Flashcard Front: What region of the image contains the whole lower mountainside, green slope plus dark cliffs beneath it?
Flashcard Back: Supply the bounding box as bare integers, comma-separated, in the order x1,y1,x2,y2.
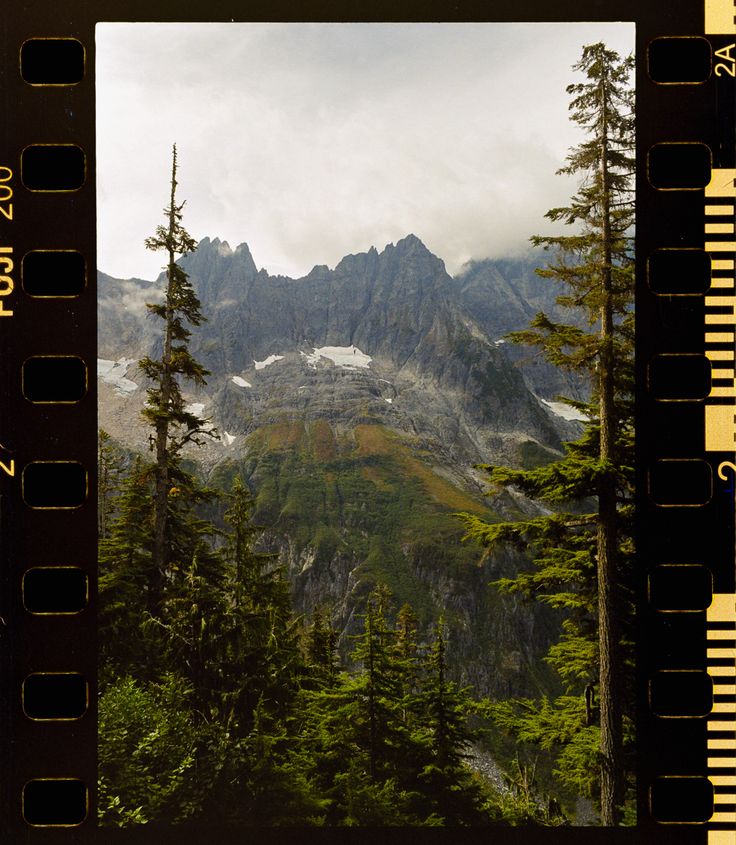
210,419,557,695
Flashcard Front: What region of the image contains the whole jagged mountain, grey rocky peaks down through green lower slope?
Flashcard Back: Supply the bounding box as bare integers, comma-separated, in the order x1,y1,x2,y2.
99,235,577,695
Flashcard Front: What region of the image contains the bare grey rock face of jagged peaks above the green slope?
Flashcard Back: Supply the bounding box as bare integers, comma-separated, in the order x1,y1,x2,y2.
99,235,570,465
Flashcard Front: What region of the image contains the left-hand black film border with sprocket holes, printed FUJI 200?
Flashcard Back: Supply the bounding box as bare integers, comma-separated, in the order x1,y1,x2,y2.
0,16,96,841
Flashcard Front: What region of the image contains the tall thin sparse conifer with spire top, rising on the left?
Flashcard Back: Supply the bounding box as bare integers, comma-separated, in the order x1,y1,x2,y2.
139,145,217,613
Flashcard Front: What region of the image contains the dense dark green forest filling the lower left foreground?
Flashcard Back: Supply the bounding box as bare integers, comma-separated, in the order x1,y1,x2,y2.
99,446,563,826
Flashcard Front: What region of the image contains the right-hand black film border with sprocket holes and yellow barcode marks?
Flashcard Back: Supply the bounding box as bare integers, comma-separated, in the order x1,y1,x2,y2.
637,0,736,845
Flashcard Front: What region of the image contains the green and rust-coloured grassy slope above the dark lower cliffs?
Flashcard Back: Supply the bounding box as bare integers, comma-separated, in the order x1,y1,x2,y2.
212,420,494,622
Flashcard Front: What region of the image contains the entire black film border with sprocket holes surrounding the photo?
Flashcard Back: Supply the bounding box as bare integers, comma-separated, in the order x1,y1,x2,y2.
0,0,736,845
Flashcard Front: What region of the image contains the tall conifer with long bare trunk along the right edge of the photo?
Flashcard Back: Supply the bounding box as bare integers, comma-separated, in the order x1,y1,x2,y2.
465,43,634,825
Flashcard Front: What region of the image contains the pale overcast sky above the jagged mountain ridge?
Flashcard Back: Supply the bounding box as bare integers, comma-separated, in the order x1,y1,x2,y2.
96,23,634,279
